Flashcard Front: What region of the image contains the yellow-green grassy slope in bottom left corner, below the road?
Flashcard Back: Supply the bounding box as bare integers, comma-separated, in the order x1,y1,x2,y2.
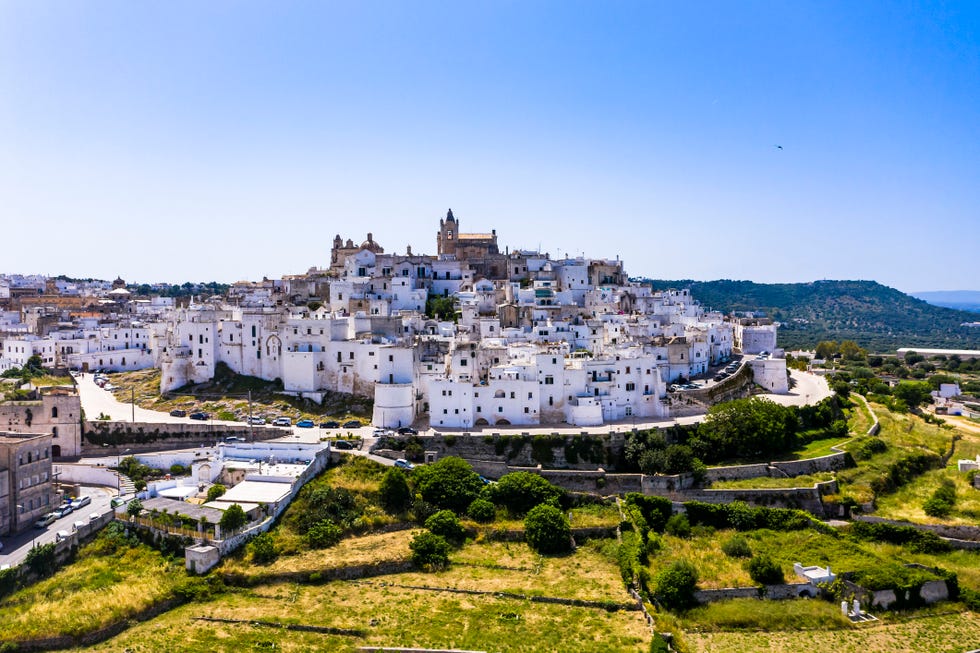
0,536,186,642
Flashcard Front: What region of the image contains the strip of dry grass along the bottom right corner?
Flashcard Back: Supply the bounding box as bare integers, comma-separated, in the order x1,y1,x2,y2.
684,606,980,653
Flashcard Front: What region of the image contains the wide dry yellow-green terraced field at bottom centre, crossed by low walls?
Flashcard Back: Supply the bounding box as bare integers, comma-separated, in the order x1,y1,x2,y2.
90,544,650,653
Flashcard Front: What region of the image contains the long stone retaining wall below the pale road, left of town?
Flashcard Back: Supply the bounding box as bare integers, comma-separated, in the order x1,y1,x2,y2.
82,421,288,456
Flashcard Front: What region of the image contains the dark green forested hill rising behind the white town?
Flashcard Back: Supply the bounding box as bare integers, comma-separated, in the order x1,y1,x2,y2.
643,279,980,352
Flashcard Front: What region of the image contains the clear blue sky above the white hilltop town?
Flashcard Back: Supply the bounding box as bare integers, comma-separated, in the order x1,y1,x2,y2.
0,0,980,291
